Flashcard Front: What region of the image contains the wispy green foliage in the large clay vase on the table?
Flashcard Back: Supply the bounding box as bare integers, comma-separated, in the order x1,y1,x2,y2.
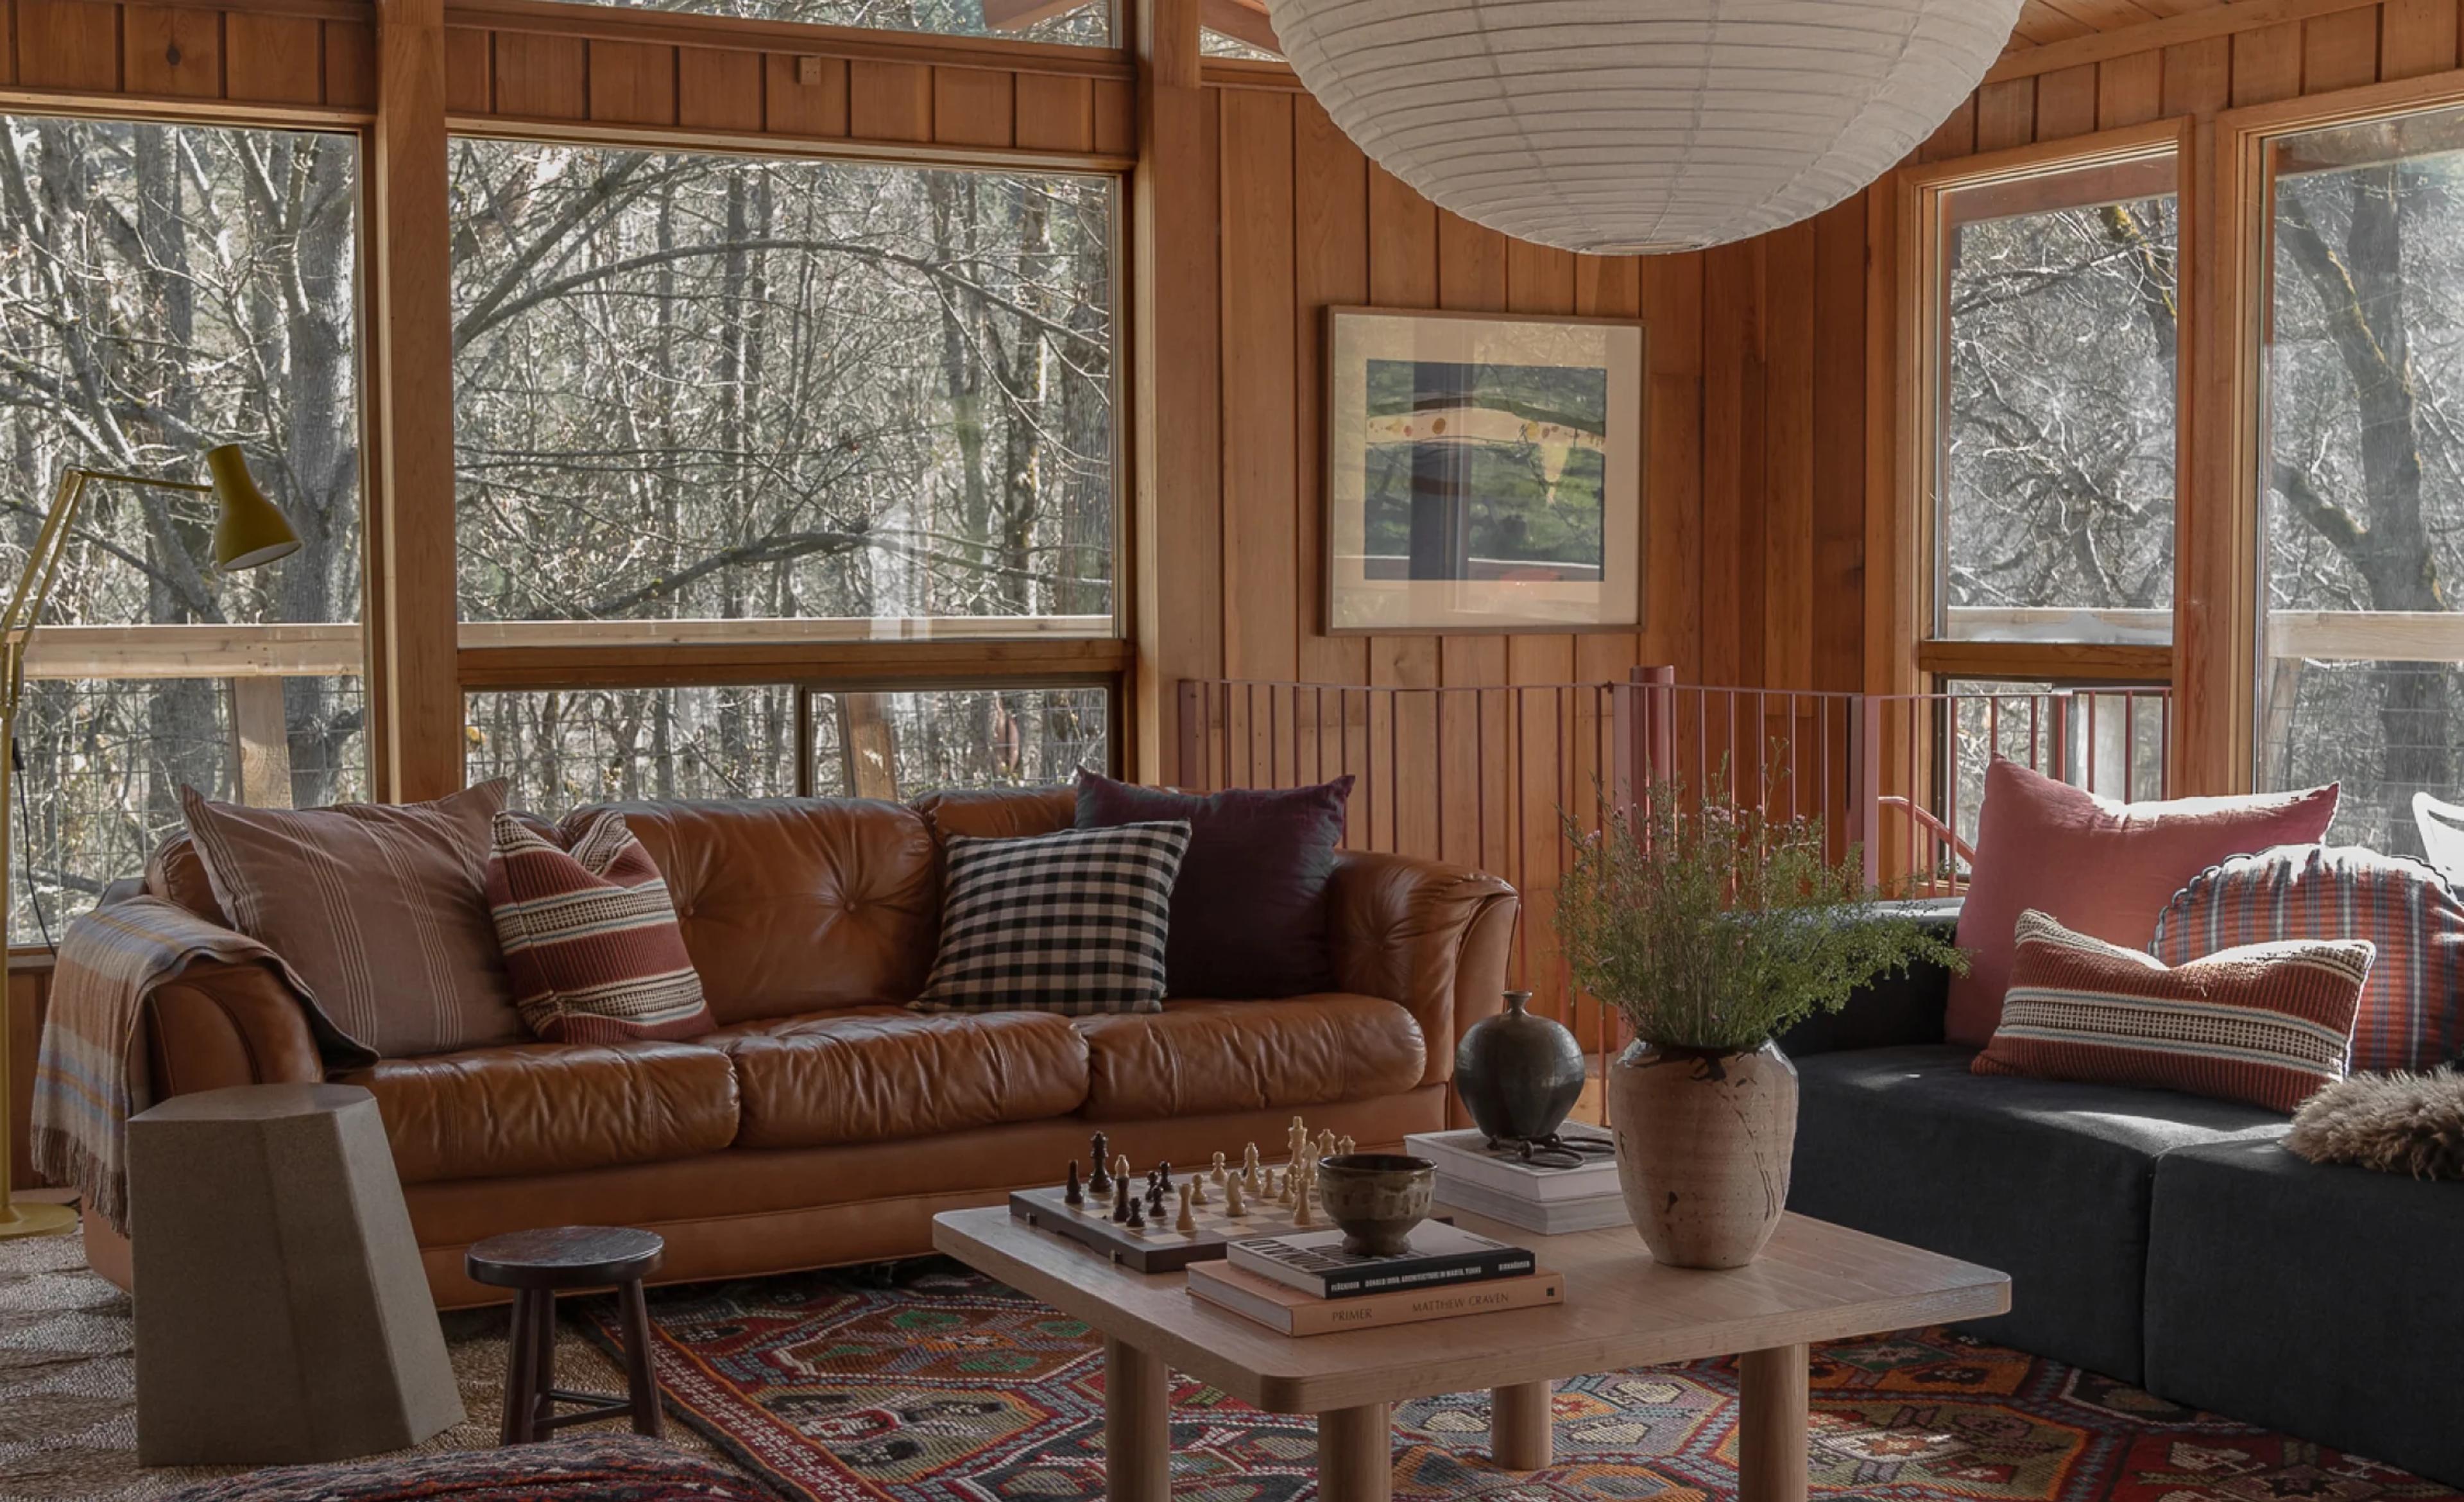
1557,775,1966,1053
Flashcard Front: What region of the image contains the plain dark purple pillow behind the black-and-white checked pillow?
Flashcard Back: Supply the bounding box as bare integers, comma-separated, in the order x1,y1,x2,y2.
1077,772,1353,1001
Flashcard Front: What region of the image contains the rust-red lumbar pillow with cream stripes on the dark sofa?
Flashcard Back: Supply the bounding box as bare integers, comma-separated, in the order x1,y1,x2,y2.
1969,910,2375,1112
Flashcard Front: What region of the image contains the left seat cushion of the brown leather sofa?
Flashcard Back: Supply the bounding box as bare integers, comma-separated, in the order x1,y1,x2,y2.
335,1043,737,1184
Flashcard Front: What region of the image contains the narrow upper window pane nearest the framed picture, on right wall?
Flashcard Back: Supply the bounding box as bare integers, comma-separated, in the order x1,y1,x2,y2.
1929,150,2180,644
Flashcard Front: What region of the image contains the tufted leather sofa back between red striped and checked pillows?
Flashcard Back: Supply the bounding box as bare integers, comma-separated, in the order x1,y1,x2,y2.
586,799,941,1024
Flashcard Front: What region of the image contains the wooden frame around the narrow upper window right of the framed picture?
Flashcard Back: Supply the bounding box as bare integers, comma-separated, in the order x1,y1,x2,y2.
1868,118,2200,691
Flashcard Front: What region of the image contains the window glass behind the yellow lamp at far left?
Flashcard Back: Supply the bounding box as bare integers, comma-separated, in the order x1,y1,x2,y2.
0,116,367,940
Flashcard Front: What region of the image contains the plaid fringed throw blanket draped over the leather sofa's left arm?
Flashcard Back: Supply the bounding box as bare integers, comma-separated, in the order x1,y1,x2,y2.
32,898,335,1233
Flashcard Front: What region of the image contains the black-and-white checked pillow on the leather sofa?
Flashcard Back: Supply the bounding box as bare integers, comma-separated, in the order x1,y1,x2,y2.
914,819,1190,1016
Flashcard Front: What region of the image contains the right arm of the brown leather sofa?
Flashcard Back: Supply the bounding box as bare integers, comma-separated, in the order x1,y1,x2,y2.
1328,851,1520,1085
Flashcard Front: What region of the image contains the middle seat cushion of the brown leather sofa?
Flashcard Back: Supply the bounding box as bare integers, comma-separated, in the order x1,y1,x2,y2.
702,1006,1086,1147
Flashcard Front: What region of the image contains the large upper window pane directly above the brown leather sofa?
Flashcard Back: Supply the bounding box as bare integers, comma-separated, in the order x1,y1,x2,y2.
454,141,1116,639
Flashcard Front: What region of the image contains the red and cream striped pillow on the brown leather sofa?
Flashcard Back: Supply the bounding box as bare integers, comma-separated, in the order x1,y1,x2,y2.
488,811,717,1043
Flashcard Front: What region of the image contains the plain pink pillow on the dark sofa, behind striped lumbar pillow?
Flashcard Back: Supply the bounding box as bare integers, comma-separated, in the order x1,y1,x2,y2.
1944,757,2336,1048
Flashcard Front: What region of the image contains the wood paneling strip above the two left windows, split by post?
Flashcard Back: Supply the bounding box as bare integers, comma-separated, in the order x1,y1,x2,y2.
0,0,1136,165
